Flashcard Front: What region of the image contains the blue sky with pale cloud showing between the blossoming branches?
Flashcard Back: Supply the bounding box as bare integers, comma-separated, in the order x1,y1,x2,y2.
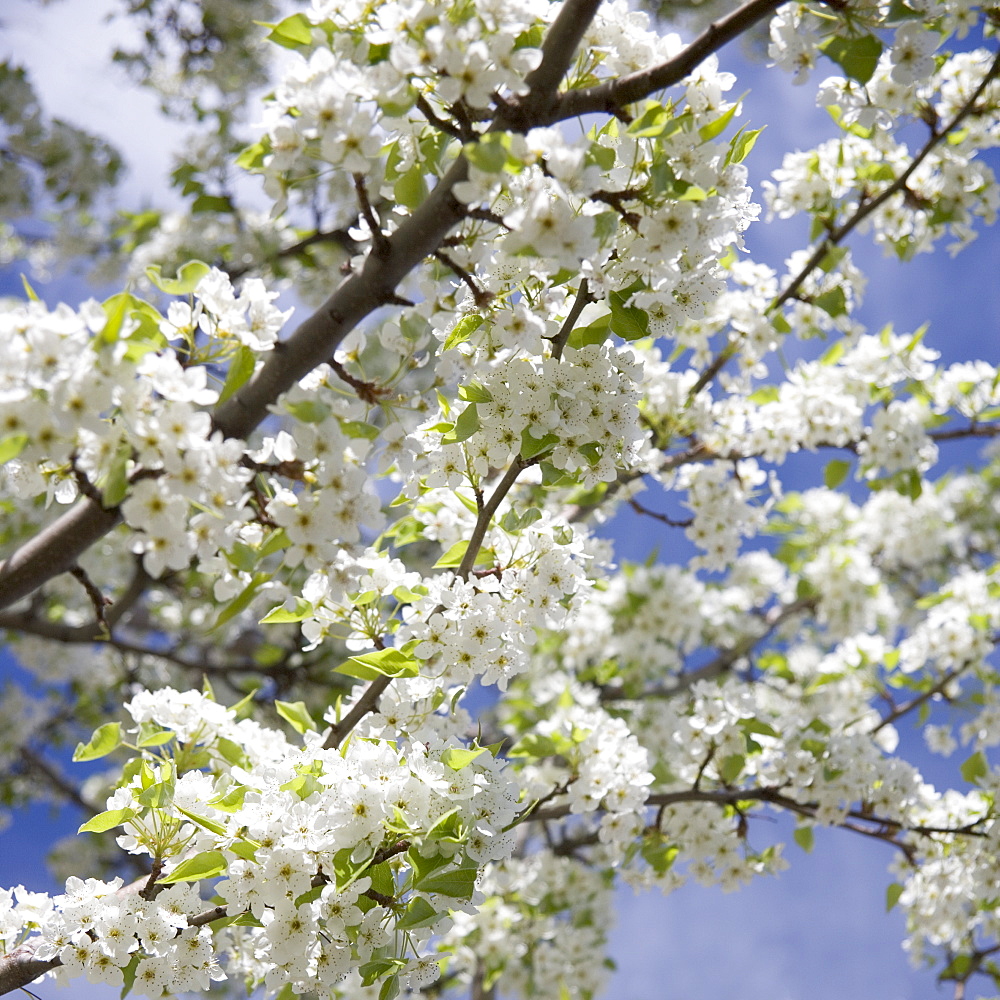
0,0,1000,1000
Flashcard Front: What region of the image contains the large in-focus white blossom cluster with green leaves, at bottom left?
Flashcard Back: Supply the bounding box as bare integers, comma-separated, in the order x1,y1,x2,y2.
0,689,517,997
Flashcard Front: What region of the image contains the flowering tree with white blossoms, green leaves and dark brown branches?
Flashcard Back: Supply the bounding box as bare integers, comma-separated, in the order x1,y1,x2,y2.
0,0,1000,1000
